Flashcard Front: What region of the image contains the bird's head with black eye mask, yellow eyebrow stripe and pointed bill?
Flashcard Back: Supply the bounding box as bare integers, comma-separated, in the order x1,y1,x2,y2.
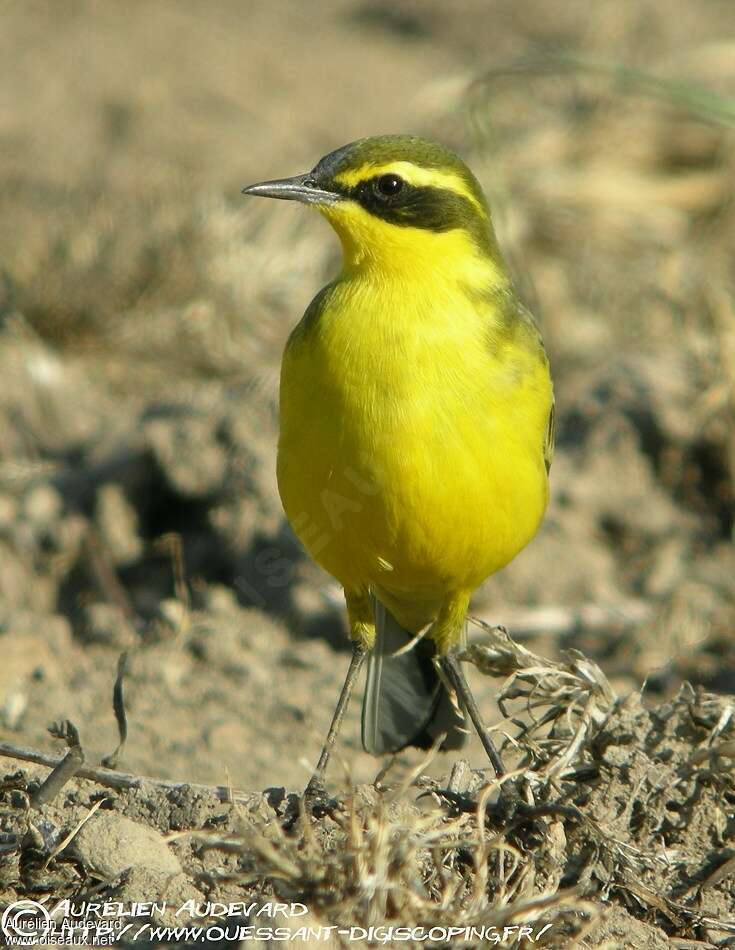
243,135,501,280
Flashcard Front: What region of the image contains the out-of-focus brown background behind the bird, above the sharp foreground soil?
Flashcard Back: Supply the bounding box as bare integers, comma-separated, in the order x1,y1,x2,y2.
0,0,735,789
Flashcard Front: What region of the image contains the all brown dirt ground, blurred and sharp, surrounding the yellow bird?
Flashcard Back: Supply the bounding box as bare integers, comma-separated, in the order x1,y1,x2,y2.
0,0,735,947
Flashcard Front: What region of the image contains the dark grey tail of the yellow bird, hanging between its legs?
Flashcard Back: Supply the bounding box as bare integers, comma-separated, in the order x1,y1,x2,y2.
362,599,467,755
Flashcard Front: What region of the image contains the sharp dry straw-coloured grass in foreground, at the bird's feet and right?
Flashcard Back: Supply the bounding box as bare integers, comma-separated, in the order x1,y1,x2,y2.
139,629,735,946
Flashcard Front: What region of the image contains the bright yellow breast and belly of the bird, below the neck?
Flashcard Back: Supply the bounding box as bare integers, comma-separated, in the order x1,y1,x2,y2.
278,276,551,624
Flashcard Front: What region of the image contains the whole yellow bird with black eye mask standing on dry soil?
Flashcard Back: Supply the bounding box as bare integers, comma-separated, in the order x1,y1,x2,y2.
243,135,554,794
